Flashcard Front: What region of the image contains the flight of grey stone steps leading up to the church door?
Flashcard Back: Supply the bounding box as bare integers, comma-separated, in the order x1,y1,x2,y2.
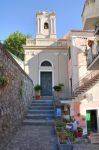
23,100,54,126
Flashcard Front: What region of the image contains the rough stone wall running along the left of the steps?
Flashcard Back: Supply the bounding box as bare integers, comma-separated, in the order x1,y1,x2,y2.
0,45,33,150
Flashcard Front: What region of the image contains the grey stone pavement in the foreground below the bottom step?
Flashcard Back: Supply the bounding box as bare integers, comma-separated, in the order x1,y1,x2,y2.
7,125,57,150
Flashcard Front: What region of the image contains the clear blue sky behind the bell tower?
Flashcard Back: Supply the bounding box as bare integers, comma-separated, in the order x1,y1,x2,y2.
0,0,84,40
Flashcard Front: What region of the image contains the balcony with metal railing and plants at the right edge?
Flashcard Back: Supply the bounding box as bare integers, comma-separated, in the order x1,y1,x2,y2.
87,38,99,70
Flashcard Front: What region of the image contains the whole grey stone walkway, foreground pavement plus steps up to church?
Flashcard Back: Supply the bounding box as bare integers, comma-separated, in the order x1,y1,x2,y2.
6,100,57,150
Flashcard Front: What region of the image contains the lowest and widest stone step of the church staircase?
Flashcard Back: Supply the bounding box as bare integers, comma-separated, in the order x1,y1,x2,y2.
23,119,54,126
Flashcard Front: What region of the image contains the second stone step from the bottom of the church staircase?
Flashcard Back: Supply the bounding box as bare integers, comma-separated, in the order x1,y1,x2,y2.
25,113,54,119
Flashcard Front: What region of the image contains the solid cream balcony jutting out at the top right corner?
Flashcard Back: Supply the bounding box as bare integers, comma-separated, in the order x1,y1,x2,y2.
82,0,99,30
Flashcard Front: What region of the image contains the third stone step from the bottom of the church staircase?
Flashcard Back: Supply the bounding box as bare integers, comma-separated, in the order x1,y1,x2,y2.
28,109,54,114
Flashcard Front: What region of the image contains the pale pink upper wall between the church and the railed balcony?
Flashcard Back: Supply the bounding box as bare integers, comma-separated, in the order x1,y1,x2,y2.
71,36,91,89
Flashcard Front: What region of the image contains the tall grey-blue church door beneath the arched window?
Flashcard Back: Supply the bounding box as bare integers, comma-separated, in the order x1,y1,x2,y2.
40,72,52,96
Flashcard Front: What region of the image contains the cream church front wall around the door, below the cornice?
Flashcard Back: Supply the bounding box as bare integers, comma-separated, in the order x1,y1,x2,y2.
25,49,69,97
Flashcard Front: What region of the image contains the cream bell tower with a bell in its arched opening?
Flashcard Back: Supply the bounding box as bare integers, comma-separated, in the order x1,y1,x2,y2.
36,11,56,39
